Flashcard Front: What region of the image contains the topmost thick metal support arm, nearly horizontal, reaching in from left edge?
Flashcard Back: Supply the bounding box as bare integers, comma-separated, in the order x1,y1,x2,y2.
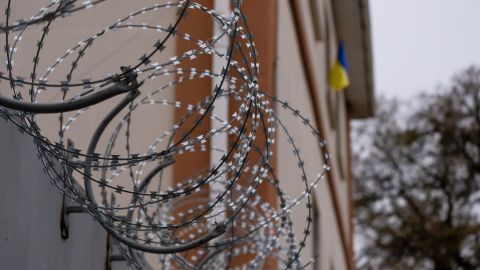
0,81,139,114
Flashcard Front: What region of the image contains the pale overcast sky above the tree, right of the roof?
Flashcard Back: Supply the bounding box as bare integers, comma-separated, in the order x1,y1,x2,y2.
370,0,480,98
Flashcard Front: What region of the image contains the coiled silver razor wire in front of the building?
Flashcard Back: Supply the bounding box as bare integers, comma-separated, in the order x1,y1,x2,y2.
0,0,329,269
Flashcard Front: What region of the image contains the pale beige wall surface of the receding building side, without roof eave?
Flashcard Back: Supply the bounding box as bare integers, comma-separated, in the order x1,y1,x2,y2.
277,0,350,269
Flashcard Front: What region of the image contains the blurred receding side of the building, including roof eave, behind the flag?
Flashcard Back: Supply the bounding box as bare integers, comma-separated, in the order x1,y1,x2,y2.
277,0,373,270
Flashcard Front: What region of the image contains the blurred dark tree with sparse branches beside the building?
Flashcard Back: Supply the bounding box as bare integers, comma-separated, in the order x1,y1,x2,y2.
352,68,480,269
